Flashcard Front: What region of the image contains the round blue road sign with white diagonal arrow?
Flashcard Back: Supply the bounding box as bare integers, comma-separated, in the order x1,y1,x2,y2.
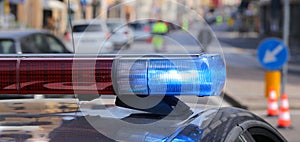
257,38,289,71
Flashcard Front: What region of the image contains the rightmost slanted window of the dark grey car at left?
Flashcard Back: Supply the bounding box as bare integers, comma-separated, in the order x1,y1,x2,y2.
45,35,65,53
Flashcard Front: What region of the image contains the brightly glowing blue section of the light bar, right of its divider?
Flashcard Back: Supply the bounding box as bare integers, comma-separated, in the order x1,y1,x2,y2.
148,59,212,95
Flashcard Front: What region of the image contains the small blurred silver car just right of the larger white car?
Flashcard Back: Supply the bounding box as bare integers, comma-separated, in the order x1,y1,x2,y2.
106,19,134,49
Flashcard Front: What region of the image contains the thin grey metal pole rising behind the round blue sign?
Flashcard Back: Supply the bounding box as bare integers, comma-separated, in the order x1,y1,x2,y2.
281,0,290,95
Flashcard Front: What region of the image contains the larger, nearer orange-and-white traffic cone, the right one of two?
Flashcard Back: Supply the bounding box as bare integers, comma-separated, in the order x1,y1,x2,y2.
278,94,291,128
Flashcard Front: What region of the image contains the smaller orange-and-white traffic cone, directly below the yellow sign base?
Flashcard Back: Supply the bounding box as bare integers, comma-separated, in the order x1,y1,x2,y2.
267,88,279,116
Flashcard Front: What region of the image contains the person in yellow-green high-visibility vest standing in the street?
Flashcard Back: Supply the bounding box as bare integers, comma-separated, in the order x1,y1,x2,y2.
152,21,168,52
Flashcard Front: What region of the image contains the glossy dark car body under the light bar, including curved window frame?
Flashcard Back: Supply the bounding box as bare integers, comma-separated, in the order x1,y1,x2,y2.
0,98,284,142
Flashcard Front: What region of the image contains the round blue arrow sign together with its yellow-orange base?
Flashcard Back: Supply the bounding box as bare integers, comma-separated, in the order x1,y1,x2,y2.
257,38,289,97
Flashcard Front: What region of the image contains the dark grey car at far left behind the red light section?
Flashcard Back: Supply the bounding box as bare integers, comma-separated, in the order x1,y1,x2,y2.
0,30,70,54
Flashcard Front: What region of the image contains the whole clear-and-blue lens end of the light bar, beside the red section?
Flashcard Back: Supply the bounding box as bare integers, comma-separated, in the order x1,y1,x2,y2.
115,55,226,96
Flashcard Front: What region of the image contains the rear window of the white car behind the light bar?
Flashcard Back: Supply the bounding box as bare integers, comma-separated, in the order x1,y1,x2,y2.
73,24,102,33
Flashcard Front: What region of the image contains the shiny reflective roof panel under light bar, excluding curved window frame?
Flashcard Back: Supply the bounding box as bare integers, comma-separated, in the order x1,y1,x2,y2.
0,99,217,142
